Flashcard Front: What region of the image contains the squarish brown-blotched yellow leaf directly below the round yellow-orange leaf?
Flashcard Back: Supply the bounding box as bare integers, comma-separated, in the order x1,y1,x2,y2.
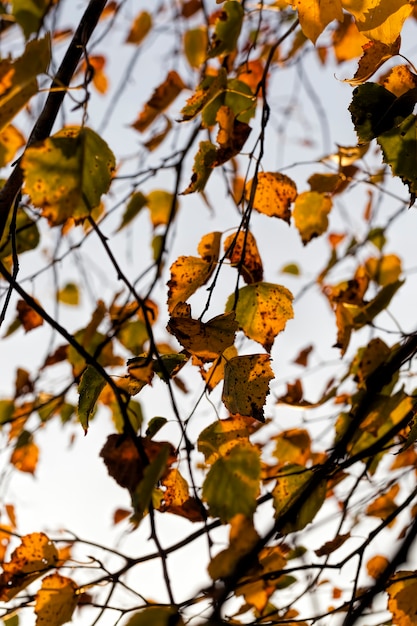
222,354,274,422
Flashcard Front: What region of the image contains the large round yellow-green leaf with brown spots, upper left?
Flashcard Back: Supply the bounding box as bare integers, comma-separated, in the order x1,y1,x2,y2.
22,127,115,226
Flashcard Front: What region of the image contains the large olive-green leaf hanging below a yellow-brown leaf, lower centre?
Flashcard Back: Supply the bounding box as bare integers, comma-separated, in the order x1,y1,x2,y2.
203,444,261,522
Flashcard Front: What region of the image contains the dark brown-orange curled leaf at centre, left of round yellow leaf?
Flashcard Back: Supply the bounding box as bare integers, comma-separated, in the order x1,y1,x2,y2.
167,309,237,361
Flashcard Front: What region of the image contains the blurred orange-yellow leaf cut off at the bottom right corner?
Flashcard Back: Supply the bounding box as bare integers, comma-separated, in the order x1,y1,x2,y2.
387,571,417,626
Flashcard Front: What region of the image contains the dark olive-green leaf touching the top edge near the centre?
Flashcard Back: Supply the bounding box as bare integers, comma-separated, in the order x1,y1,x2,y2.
208,0,244,59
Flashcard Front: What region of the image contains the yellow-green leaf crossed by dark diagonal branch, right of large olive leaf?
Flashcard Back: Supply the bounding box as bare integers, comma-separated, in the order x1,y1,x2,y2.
272,463,326,534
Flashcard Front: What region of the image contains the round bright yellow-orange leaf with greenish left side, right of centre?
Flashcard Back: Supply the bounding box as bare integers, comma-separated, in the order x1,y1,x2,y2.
226,282,294,352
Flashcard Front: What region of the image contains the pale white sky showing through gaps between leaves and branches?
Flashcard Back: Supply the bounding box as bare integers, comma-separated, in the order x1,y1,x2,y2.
0,1,417,626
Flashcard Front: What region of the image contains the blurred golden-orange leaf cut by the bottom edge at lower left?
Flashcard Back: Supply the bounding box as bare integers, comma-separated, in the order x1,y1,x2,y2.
35,573,77,626
